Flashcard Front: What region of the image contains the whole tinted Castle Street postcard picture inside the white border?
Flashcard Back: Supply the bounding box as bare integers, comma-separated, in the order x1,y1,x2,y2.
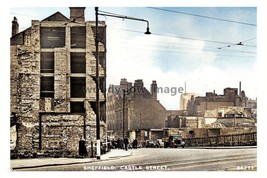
9,6,258,172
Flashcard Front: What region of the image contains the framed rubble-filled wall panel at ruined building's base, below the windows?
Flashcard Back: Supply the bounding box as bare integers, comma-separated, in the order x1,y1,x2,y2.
41,114,84,153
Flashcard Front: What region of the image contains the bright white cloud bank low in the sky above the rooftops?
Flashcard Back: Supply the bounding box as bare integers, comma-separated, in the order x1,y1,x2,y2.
107,23,256,109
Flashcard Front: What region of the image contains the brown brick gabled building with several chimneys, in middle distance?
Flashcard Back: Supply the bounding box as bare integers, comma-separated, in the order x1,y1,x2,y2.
107,79,167,138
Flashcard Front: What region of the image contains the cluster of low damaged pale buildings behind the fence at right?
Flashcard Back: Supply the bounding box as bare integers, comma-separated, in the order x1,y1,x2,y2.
175,82,257,131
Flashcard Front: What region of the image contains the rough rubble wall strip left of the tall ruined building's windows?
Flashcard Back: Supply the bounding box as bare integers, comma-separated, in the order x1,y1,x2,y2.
11,21,40,151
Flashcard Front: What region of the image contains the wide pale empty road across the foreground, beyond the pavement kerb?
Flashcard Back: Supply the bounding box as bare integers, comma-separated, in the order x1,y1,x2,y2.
16,148,257,171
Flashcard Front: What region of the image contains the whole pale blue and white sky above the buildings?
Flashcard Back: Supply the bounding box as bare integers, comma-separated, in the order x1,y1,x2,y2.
9,7,257,110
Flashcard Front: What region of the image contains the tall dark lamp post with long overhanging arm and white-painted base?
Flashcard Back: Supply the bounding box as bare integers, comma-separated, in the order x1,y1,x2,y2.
95,7,151,159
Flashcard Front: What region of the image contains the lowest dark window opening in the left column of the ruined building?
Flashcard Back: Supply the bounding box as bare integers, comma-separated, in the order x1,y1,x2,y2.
40,77,54,98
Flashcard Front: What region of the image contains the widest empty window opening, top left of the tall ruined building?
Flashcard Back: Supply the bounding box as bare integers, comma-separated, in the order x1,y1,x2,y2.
41,27,66,48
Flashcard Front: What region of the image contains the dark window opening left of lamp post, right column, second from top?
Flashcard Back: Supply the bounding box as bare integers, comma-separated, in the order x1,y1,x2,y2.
70,53,86,73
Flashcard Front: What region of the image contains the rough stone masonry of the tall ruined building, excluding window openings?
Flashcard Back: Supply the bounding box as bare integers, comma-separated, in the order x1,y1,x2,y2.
10,20,106,154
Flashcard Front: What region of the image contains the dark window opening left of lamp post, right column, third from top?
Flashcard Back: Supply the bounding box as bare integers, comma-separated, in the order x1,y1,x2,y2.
70,77,86,98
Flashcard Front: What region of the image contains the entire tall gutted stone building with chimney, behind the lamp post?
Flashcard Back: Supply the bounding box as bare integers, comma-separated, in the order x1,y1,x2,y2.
10,7,106,155
